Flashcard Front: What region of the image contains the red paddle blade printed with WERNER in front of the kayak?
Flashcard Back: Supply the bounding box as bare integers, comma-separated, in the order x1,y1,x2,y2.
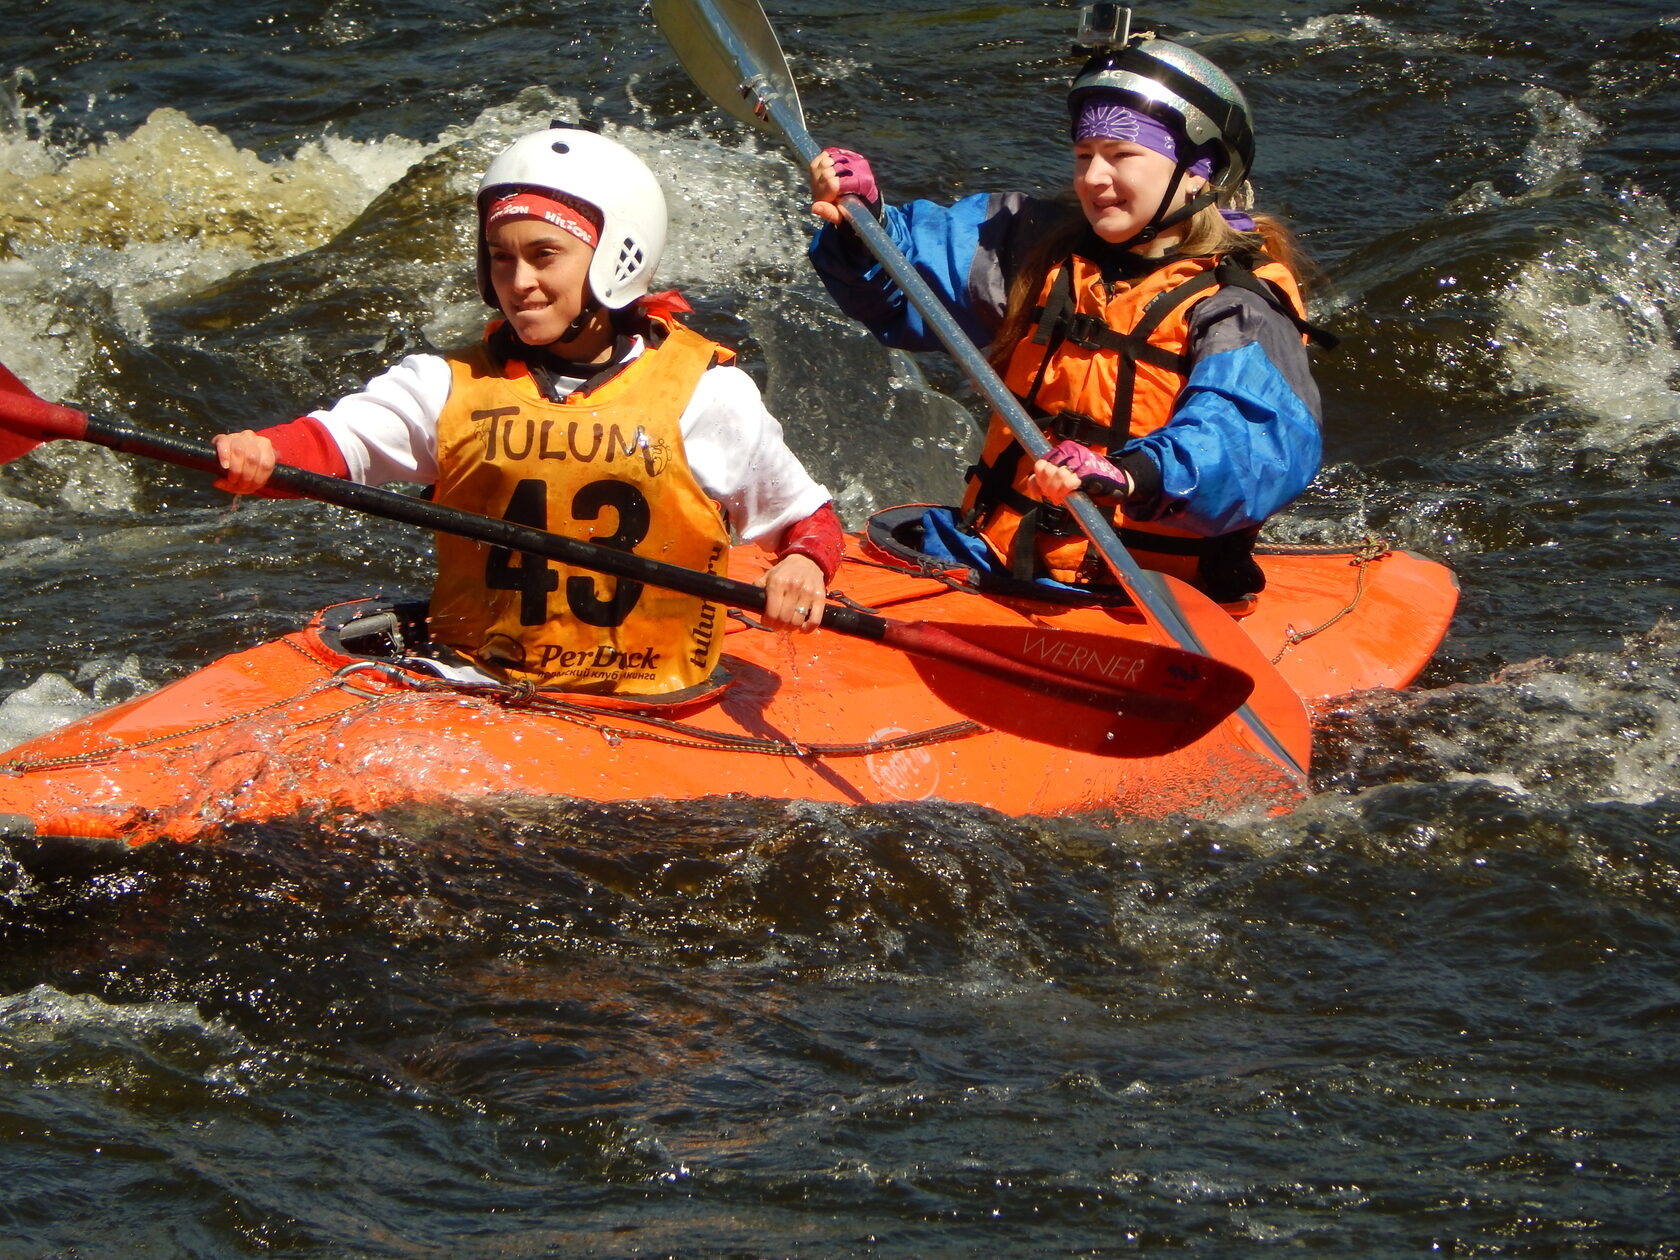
887,622,1253,758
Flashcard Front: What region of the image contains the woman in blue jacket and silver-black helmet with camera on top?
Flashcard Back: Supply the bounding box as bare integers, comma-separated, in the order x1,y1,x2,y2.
811,29,1320,601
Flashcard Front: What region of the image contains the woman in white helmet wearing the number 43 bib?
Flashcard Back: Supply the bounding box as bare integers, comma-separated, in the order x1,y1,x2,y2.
217,124,842,696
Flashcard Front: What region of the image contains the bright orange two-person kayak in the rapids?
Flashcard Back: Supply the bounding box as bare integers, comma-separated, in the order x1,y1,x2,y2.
0,517,1458,845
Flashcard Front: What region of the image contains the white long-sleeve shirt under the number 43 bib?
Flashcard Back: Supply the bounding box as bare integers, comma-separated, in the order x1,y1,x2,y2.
311,338,832,548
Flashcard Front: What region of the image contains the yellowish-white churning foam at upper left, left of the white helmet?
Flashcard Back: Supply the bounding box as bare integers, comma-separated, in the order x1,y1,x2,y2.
0,86,510,389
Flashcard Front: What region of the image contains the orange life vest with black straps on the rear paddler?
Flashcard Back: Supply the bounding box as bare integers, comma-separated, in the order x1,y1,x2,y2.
963,254,1307,583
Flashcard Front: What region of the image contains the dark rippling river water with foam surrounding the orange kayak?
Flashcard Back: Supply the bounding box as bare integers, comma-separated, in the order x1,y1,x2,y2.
0,0,1680,1260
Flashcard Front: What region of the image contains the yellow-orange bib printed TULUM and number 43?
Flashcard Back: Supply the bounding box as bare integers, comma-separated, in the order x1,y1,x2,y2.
432,321,734,696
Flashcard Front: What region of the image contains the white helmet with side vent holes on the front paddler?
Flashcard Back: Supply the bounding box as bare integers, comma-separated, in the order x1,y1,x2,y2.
479,123,667,311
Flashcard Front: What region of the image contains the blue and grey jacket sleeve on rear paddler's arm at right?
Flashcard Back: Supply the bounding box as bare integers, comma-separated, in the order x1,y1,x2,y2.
1122,291,1324,538
